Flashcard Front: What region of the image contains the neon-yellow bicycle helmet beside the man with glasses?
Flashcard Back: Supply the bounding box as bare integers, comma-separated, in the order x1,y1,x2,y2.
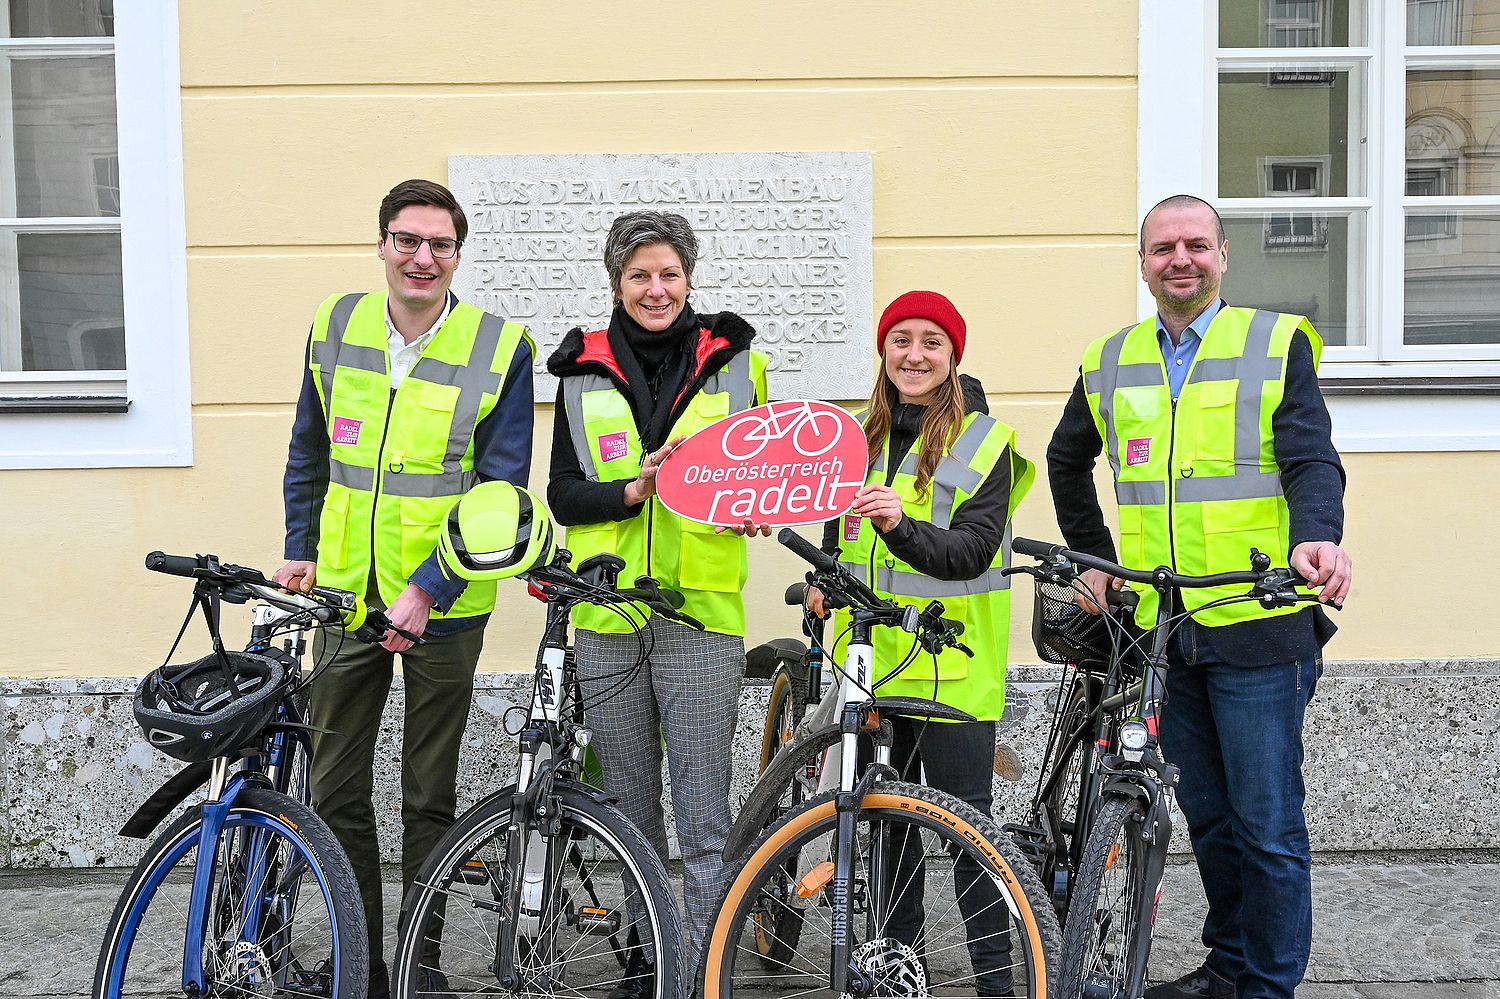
438,480,557,581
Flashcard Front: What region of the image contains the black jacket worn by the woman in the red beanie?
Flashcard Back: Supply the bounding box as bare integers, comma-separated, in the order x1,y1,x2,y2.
824,375,1011,579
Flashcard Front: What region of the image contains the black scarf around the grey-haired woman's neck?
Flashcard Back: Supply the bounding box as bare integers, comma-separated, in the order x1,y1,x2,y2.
609,303,698,450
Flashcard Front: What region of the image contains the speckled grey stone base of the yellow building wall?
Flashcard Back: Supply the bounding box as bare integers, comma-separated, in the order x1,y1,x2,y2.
0,660,1500,869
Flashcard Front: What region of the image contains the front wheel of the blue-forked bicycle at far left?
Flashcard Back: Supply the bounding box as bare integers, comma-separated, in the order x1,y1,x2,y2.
92,788,369,999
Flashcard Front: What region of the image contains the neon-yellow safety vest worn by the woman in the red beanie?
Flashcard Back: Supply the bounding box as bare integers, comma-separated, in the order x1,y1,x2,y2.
833,413,1037,722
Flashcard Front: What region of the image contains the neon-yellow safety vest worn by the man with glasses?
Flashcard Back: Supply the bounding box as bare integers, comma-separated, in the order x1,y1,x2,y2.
308,293,534,618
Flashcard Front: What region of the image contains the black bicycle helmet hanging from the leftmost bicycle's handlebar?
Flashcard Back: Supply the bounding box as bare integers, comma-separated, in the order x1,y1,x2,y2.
134,653,287,764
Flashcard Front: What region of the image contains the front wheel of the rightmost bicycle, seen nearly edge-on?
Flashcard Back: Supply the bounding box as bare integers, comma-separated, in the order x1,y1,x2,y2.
1062,795,1155,999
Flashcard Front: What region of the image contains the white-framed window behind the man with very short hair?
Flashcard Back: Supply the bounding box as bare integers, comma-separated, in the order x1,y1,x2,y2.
1142,0,1500,366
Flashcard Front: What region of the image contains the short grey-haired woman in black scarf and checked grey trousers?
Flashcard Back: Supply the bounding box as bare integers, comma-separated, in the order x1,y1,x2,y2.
548,212,770,978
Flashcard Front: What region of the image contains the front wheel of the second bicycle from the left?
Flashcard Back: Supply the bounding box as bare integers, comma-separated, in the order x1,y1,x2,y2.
392,780,683,999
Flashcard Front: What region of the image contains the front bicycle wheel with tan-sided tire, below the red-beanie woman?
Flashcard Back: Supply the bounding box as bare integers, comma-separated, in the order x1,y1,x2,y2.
702,782,1059,999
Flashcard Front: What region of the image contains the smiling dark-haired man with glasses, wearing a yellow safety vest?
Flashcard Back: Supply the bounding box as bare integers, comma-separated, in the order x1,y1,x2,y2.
276,180,536,999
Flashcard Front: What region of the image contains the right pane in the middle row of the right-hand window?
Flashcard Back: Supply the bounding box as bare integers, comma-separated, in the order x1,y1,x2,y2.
1406,69,1500,197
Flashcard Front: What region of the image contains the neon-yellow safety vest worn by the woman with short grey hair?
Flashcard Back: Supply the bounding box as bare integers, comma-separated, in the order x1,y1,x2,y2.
563,339,770,636
